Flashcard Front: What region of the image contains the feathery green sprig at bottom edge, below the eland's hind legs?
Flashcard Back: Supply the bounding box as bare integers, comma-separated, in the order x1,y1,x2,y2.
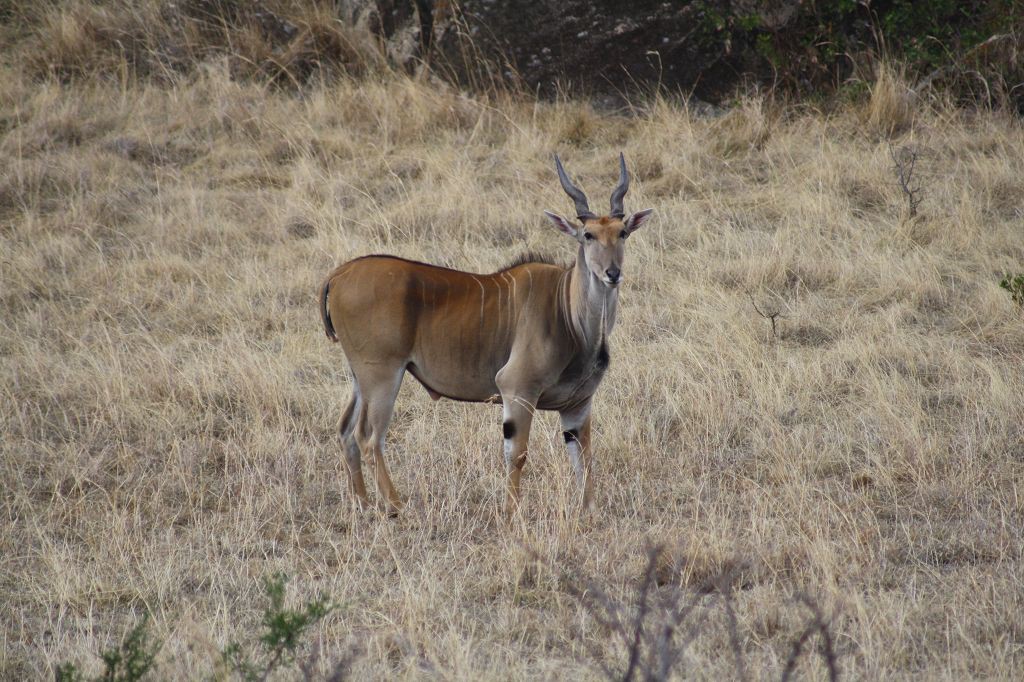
221,572,334,682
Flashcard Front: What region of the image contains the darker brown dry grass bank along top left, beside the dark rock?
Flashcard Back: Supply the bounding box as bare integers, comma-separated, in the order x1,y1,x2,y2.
11,0,384,87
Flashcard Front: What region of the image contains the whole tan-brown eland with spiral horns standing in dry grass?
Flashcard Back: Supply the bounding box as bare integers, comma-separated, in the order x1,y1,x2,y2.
319,155,653,513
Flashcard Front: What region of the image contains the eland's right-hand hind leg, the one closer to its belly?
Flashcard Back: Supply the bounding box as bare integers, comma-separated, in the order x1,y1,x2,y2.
353,365,406,515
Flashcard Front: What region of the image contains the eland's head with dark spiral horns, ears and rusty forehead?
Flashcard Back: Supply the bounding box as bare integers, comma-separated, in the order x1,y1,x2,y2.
544,154,654,289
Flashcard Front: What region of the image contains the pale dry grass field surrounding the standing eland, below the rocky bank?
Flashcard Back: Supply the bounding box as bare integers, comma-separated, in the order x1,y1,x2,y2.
0,7,1024,679
